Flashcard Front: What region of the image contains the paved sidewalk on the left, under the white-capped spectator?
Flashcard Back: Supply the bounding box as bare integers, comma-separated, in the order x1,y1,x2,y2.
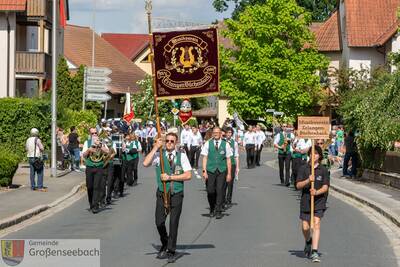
0,165,85,230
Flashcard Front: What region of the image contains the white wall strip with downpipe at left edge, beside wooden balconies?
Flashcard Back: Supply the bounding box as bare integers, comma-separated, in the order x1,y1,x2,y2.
0,13,16,97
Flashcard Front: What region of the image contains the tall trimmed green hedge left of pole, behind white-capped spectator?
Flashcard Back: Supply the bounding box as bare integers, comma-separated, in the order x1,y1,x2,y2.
0,98,51,159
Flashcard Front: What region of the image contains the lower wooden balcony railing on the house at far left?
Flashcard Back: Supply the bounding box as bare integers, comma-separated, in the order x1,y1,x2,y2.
15,52,51,76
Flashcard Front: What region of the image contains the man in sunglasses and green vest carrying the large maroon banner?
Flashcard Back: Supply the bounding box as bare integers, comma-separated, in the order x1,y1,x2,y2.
143,133,192,263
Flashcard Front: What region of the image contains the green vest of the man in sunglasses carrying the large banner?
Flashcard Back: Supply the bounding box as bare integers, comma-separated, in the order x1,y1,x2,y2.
156,150,183,194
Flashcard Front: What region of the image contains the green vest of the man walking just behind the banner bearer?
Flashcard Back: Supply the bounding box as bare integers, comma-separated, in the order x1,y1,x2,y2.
207,139,227,173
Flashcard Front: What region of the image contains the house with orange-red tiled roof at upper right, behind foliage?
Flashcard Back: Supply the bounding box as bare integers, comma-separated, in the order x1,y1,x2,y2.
311,0,400,79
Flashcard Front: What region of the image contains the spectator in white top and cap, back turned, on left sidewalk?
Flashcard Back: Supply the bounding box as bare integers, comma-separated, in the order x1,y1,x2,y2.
25,128,46,192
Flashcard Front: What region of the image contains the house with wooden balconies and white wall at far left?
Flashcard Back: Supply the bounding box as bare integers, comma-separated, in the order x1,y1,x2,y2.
0,0,69,97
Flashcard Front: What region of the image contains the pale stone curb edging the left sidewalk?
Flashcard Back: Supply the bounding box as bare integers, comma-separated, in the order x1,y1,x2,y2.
0,182,85,230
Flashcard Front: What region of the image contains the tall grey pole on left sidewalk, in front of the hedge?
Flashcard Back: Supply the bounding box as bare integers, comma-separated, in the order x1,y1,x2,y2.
51,0,58,177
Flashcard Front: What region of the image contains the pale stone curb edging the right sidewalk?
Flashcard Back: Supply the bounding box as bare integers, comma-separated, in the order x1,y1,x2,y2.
264,160,400,227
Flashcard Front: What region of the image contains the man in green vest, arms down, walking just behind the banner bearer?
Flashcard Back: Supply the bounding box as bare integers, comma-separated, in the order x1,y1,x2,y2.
201,127,233,219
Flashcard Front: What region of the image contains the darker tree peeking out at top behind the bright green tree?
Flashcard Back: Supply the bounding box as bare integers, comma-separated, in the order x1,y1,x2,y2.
213,0,337,21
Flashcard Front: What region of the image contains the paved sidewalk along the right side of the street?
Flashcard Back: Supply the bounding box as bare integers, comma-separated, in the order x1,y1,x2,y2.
265,160,400,227
